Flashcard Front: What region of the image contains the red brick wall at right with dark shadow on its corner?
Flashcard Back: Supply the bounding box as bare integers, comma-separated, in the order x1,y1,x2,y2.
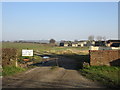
89,50,120,66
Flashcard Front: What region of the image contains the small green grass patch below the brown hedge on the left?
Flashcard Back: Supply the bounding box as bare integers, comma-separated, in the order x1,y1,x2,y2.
2,66,27,76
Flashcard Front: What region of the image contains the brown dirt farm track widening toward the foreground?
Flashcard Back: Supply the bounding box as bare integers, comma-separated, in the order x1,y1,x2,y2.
3,57,104,88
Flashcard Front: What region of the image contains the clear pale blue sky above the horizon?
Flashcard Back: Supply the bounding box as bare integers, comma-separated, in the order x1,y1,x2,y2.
2,2,118,41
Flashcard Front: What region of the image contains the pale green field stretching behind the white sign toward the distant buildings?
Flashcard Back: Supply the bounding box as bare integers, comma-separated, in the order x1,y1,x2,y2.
2,42,89,54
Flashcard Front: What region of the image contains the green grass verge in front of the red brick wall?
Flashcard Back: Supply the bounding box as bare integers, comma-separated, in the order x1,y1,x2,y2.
80,66,120,88
